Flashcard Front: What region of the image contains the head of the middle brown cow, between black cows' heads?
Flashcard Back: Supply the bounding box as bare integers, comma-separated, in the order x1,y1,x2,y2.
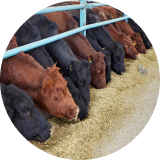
88,52,106,89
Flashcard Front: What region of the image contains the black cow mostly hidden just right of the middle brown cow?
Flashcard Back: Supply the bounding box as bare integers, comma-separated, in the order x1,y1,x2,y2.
72,15,111,84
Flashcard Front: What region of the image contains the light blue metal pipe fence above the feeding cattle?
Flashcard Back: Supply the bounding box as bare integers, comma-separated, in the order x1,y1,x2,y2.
0,0,160,59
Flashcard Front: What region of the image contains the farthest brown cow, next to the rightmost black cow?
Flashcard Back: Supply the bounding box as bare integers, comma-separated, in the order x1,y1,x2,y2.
100,6,146,53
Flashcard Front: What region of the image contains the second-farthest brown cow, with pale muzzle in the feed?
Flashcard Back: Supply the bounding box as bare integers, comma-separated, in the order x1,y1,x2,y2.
91,7,140,59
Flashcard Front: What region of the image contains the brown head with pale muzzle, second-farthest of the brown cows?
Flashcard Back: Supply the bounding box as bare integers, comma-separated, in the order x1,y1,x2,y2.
119,32,140,59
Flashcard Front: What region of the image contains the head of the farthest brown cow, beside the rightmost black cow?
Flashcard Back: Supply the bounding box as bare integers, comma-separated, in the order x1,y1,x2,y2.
131,33,146,53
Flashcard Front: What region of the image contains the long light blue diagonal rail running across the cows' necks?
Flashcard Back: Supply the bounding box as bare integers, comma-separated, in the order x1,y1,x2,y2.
2,16,130,59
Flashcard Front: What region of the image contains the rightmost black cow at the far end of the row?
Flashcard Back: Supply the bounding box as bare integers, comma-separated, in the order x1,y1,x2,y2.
128,18,152,49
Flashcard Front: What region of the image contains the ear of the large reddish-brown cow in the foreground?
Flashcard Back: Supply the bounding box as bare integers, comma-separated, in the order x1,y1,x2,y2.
41,76,54,96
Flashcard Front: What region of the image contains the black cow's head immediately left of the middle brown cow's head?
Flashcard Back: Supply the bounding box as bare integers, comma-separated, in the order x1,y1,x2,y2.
69,59,92,105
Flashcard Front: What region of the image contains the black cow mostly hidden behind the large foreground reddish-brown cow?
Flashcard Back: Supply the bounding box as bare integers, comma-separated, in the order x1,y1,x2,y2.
14,19,88,120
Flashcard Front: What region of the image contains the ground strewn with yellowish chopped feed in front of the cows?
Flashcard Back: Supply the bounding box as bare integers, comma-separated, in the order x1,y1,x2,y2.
29,47,160,160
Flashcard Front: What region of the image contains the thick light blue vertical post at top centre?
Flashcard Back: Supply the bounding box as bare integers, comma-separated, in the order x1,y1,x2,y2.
80,0,86,36
